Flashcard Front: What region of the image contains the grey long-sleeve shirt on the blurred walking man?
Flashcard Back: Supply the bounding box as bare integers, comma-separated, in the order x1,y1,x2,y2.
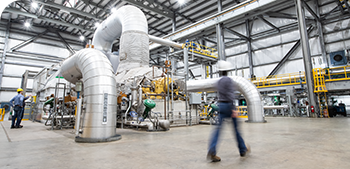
216,76,236,103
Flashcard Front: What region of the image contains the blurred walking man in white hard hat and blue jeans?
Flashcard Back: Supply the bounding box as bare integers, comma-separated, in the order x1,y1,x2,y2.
207,61,250,162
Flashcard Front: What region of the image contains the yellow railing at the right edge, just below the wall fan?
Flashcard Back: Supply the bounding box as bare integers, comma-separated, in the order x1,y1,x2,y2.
324,66,350,82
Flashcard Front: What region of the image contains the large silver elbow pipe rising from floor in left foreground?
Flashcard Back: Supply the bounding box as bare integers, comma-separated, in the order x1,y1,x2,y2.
61,49,121,142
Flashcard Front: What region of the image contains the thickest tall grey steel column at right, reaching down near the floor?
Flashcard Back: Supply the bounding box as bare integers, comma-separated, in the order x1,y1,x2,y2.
296,0,318,117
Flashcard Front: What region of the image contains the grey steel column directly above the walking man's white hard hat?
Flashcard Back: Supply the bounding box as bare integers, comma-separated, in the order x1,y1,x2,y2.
216,0,226,60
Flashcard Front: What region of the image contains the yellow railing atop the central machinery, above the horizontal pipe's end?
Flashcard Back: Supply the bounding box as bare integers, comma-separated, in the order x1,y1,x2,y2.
182,42,218,59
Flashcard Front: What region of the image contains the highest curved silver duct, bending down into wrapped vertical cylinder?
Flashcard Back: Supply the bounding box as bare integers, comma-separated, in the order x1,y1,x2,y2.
92,5,149,72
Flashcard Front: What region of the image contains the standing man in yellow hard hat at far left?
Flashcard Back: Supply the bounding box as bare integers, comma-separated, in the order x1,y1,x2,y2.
10,88,24,129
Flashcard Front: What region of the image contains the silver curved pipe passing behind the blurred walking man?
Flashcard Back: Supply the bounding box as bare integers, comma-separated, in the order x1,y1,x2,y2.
187,76,266,123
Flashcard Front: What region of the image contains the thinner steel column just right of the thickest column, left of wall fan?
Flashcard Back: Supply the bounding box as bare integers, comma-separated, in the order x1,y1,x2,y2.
316,0,329,67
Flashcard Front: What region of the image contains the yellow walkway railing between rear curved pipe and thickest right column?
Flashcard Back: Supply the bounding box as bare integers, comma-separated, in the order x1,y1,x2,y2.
249,72,306,88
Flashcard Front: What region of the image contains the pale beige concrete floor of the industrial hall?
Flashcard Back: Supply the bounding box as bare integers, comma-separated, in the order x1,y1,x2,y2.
0,117,350,169
